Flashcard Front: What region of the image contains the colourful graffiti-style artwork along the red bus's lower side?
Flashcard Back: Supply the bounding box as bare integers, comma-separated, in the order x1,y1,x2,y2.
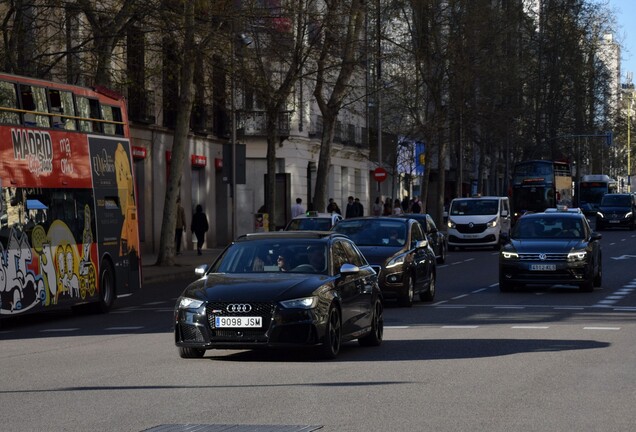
0,206,97,314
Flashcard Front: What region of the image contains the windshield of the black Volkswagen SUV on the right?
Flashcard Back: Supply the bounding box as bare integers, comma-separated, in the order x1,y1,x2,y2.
511,217,584,239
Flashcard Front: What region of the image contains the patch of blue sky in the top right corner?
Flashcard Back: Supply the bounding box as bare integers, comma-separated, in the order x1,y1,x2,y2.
608,0,636,83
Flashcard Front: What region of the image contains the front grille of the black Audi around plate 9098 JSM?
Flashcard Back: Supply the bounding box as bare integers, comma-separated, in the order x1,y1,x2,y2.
206,302,276,342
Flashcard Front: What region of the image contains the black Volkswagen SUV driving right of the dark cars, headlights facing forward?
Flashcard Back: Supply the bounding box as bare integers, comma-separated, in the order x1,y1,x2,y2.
499,211,603,292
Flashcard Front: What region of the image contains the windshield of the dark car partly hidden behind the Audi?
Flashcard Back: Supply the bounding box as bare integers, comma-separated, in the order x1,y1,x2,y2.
333,219,407,247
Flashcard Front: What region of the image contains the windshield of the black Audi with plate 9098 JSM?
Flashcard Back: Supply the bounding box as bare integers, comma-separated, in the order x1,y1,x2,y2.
212,239,329,274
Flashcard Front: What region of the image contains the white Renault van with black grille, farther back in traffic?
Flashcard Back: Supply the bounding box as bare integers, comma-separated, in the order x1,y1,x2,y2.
448,196,511,250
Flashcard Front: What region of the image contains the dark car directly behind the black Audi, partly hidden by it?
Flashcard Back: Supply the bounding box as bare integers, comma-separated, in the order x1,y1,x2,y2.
332,216,436,307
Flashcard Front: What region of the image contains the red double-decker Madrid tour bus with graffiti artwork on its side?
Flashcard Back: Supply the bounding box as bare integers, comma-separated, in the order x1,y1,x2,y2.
0,74,141,318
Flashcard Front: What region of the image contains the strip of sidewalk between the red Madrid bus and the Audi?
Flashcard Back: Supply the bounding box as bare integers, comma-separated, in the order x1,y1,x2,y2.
141,248,223,284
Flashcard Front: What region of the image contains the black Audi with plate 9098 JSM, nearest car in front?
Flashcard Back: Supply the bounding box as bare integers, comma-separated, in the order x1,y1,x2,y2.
174,231,384,358
